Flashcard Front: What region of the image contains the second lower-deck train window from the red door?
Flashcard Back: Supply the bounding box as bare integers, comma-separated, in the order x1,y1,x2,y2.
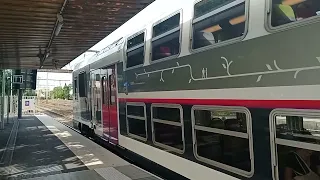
151,104,185,154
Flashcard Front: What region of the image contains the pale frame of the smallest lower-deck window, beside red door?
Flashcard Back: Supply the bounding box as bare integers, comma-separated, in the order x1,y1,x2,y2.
126,102,148,142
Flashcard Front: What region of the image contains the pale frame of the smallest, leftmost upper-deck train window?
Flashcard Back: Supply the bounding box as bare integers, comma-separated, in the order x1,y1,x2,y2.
123,29,147,71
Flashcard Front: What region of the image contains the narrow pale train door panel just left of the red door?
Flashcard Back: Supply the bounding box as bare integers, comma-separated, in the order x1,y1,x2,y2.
90,69,103,136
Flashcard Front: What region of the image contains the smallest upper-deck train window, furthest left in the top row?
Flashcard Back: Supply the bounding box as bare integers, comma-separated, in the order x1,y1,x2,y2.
127,32,145,68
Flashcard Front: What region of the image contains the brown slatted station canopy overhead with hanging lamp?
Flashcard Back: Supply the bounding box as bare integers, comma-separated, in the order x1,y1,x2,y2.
0,0,154,69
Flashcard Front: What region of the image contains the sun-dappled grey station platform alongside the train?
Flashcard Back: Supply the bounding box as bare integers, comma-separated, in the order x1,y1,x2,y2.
0,115,160,180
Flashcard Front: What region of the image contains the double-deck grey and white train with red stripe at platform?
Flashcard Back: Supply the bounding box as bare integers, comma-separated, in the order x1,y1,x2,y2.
73,0,320,180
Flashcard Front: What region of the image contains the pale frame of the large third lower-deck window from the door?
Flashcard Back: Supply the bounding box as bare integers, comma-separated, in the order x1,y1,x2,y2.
191,105,254,178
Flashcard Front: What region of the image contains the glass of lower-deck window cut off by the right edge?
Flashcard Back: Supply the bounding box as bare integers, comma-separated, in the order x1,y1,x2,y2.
276,116,320,180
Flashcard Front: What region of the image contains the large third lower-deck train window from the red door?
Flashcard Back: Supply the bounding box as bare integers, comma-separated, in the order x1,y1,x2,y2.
192,106,254,177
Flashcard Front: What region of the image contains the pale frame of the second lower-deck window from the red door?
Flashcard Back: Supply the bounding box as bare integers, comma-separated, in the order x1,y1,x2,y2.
150,103,186,154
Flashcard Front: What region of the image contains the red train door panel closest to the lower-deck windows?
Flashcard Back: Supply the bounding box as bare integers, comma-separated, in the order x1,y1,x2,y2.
102,65,118,144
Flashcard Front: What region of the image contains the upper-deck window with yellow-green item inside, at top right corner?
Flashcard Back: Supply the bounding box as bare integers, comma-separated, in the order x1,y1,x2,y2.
271,0,320,27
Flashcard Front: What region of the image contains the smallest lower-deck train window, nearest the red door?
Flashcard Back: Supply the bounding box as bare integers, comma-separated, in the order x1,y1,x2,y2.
126,103,147,141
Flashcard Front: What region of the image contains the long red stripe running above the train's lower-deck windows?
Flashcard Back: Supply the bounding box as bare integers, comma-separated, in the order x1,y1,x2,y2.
119,98,320,109
